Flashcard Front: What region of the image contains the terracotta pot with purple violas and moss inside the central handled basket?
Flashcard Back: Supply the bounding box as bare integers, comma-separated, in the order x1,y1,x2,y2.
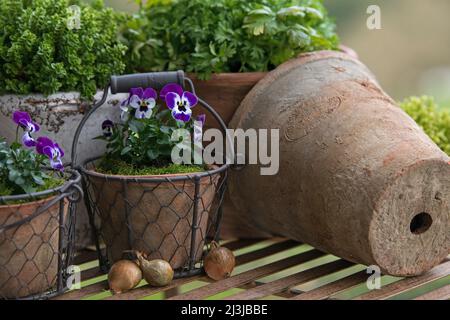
79,83,227,269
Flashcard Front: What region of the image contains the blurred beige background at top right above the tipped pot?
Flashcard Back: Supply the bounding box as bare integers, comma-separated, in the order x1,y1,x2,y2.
96,0,450,108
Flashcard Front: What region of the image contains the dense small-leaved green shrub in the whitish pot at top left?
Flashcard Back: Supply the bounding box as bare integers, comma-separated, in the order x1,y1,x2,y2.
0,0,126,98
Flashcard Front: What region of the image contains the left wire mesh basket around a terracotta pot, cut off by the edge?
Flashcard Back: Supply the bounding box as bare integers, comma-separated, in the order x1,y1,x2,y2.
0,170,83,300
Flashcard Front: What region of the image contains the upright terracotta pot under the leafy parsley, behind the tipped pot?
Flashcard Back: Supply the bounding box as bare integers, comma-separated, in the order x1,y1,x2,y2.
188,72,267,128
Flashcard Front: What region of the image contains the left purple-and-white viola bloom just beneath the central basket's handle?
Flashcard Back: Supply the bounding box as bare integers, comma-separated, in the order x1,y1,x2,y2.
120,88,158,121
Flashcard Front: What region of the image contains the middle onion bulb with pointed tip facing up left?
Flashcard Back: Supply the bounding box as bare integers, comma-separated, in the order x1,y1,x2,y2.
138,254,173,287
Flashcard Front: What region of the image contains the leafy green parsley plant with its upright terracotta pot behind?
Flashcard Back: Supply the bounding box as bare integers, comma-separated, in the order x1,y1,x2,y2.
121,0,339,127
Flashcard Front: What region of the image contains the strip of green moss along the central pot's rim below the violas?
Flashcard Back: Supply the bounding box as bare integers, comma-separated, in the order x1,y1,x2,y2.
96,160,206,176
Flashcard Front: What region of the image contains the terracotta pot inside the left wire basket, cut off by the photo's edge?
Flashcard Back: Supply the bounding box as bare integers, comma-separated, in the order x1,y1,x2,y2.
0,197,68,298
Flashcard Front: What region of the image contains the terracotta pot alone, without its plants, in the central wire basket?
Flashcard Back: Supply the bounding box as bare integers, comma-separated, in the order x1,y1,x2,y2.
85,165,220,269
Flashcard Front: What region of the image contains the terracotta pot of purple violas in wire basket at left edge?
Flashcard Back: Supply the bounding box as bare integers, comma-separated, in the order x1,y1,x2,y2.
0,111,77,298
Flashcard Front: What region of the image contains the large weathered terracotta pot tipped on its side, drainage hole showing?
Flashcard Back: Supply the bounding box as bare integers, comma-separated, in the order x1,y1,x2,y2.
222,51,450,277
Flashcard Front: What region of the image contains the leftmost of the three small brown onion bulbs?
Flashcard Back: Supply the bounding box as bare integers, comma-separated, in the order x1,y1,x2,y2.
108,260,142,294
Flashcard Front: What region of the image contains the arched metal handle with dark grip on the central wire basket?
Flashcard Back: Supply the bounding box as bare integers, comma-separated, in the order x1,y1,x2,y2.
71,70,235,168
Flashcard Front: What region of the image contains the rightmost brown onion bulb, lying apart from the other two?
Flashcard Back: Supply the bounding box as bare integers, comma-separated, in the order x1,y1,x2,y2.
204,241,236,280
